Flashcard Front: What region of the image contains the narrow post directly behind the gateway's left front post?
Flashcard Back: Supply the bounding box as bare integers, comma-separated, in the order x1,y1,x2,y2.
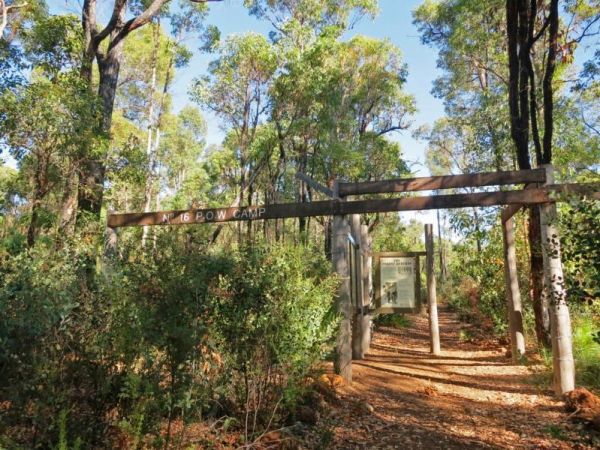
350,214,366,359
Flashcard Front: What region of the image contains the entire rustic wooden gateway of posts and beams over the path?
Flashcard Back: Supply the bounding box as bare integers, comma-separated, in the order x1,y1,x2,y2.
107,166,600,394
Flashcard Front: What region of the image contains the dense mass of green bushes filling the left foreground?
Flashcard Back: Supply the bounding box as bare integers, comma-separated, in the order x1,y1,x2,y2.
0,239,335,448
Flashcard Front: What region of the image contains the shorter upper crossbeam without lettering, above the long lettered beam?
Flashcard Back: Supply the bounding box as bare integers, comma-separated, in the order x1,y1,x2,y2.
339,169,546,196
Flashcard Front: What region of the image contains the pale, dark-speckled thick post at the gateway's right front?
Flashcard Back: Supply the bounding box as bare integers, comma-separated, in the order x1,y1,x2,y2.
539,164,575,396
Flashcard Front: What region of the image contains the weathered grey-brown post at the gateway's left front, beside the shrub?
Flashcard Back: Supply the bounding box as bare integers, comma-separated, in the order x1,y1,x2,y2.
331,182,352,383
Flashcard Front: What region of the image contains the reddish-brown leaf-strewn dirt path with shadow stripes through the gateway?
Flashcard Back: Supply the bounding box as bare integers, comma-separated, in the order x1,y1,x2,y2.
327,308,593,449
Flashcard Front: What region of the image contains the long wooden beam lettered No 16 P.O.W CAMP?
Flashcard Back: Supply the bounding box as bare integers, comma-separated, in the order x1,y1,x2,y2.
107,183,600,228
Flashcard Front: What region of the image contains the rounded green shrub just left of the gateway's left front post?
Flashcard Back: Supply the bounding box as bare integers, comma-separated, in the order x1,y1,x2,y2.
210,246,336,434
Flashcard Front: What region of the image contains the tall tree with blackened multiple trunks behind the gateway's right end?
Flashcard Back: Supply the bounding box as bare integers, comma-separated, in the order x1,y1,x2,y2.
415,0,598,343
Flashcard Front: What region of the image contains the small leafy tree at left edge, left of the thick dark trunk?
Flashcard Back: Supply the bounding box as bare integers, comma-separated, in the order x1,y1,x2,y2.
0,74,99,246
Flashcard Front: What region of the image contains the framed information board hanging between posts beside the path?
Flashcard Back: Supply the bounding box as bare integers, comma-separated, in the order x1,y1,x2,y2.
373,252,421,314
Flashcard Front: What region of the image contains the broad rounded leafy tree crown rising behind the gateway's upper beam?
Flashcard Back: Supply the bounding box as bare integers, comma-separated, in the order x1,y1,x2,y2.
272,30,414,239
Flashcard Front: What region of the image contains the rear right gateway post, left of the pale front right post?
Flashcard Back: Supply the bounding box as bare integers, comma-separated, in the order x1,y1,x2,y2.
502,217,525,363
